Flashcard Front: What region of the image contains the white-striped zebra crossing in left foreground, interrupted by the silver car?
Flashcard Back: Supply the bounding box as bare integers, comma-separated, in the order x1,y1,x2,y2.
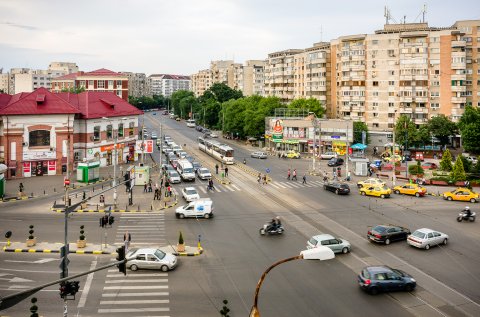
98,212,170,317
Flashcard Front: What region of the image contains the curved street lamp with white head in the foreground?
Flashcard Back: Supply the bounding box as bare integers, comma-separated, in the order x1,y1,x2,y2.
249,246,335,317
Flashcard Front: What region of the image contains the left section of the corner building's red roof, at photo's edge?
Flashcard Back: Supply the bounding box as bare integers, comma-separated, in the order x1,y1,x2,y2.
0,87,80,115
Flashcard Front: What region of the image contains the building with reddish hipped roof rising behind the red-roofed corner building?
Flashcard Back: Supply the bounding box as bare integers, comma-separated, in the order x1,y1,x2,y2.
51,68,128,101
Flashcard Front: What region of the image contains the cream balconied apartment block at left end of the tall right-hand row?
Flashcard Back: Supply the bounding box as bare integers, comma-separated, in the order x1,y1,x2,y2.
265,49,303,103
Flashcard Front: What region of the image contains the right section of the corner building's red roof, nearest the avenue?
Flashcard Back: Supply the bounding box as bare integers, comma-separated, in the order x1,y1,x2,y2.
57,91,143,119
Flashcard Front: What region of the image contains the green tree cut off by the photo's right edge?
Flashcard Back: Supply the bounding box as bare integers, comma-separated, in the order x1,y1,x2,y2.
458,106,480,153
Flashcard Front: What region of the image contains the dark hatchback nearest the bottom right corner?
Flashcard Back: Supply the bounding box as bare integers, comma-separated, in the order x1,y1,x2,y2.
358,266,417,295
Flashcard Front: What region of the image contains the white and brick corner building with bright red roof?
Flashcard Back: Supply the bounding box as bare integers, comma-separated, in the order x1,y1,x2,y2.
0,88,143,178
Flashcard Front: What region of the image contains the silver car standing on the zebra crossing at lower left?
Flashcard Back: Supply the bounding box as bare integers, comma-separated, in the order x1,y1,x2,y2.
125,248,177,272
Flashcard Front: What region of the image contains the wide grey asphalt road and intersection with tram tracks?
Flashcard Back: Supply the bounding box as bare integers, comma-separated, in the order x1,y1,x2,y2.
0,114,480,316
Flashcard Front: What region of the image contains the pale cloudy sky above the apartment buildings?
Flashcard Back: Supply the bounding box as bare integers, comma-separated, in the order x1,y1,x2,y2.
0,0,480,75
